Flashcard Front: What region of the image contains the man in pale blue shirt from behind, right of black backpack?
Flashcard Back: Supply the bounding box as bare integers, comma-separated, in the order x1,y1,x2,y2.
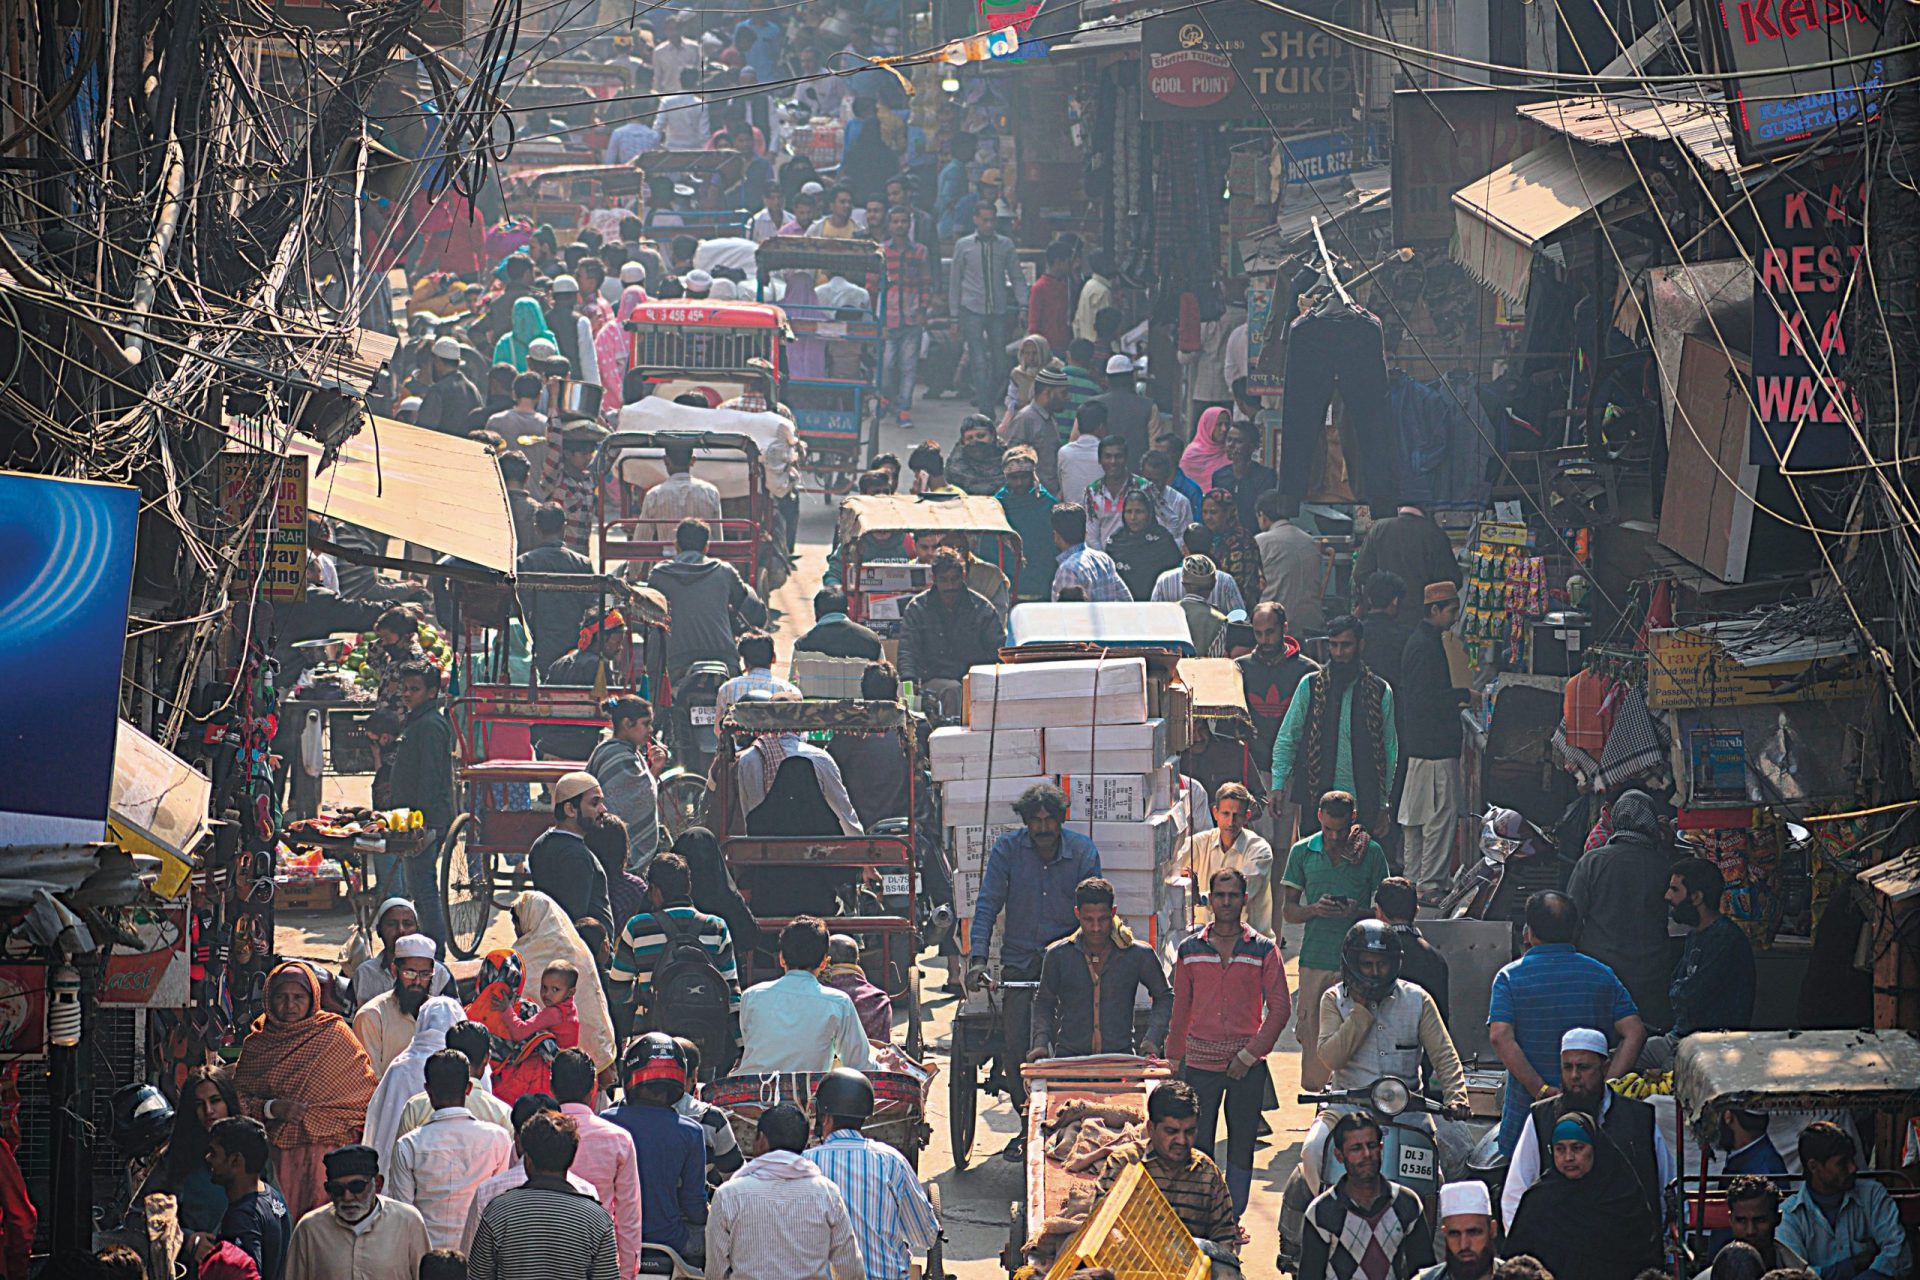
733,915,874,1074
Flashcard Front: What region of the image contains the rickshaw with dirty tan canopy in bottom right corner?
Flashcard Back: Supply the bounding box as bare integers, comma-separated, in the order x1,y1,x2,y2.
1653,1031,1920,1280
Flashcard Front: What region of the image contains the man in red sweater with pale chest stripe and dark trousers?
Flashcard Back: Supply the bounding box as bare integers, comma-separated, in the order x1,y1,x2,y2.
1167,867,1292,1213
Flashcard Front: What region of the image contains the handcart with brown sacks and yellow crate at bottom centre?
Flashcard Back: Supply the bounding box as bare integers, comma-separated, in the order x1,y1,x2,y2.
1000,1054,1182,1280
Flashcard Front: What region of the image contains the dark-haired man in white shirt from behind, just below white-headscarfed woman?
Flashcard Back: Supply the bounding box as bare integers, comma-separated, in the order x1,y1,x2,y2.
392,1050,513,1249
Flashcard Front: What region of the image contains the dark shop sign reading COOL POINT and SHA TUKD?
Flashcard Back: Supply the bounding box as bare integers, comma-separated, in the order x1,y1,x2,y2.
1140,0,1357,127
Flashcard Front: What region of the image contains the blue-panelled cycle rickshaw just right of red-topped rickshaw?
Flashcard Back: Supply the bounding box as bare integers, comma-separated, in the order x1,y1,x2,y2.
755,236,887,501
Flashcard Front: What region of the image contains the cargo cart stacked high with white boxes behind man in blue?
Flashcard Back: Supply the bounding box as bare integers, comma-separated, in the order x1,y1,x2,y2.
927,629,1192,1167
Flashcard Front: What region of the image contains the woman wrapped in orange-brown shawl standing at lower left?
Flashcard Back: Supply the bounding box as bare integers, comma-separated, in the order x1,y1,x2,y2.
234,961,378,1221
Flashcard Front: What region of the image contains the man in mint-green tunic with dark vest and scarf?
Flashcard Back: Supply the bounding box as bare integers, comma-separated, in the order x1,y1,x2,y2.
1256,616,1400,839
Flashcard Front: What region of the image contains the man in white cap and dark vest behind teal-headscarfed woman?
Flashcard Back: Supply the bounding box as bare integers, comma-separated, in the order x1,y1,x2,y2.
1500,1027,1674,1222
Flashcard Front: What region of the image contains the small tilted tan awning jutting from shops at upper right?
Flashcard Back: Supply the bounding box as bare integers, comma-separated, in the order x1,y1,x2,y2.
1453,138,1638,303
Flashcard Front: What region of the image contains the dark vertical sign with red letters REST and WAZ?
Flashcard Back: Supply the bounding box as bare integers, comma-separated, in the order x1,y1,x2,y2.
1749,163,1870,472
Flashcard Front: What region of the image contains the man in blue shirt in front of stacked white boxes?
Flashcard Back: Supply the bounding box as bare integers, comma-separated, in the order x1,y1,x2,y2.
966,783,1100,1161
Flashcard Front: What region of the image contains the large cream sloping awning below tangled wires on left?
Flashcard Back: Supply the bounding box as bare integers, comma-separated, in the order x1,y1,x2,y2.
292,418,515,574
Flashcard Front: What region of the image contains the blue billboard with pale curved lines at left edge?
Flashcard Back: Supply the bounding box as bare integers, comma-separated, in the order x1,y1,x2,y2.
0,472,140,844
